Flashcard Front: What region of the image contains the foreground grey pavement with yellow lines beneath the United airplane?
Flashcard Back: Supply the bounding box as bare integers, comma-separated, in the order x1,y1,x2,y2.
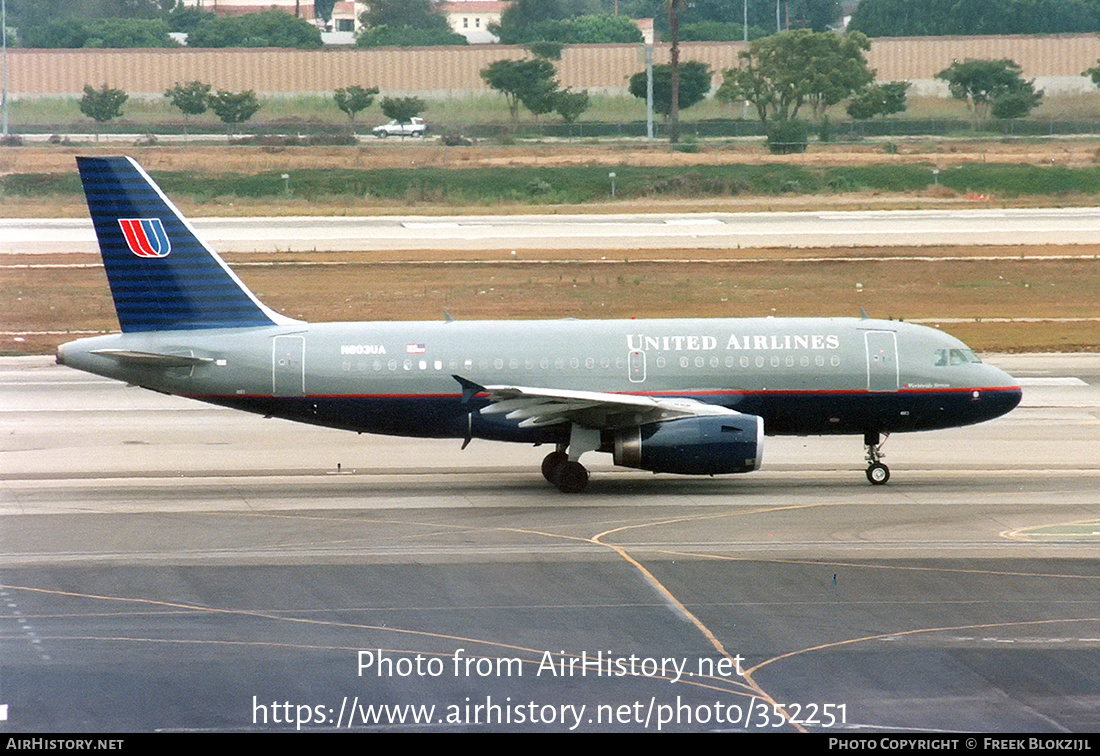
0,355,1100,733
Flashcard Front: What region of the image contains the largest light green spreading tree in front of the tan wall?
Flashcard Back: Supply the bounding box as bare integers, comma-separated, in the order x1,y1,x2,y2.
717,29,875,123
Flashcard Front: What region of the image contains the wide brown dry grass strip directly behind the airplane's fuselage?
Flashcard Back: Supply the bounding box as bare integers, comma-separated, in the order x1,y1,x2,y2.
0,248,1100,353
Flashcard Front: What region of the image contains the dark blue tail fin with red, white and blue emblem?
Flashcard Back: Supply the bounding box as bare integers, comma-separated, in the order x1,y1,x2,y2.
76,157,288,331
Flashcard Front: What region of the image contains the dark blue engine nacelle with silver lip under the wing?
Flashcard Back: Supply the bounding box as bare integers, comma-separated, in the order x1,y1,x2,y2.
613,415,763,475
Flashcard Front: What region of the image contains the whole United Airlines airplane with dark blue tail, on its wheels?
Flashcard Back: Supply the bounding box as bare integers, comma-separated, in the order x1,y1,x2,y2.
57,157,1022,493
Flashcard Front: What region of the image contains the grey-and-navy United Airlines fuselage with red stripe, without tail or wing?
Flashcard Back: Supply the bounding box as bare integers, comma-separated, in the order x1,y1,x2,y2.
58,318,1021,442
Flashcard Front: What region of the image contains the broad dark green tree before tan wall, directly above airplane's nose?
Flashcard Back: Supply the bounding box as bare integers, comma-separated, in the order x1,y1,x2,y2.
936,58,1043,127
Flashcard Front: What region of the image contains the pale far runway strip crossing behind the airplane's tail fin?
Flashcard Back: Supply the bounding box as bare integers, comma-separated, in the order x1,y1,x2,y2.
10,208,1100,254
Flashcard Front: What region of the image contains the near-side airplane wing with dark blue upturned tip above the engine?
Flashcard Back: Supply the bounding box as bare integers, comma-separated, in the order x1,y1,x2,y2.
454,375,739,428
